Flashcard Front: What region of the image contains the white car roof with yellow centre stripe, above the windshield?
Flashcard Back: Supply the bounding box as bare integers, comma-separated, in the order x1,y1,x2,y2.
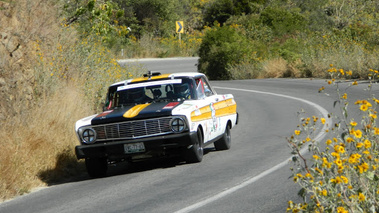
111,72,205,86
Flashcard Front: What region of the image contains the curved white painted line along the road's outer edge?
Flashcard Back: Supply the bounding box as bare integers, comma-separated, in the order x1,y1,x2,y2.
175,86,332,213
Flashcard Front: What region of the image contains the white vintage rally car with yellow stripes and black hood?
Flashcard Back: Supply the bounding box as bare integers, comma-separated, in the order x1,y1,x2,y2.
75,72,238,177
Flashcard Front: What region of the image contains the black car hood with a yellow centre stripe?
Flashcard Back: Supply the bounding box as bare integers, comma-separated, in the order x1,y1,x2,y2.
91,102,182,125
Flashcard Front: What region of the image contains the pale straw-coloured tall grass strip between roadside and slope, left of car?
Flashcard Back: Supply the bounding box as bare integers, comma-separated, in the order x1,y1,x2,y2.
0,85,90,199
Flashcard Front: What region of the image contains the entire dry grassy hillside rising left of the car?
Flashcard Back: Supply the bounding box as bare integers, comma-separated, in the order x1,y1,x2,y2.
0,0,139,201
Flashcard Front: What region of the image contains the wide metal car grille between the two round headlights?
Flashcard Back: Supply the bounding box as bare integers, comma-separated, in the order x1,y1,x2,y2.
92,117,172,141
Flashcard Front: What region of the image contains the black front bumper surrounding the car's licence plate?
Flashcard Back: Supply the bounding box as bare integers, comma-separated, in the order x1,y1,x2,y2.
75,132,197,160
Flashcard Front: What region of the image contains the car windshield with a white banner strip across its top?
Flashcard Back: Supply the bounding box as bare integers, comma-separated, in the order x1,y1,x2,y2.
107,78,196,109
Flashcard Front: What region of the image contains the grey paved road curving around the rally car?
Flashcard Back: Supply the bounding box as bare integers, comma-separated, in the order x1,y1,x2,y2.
0,58,374,213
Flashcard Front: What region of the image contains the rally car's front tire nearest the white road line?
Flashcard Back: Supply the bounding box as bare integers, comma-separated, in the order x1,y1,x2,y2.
184,129,204,163
